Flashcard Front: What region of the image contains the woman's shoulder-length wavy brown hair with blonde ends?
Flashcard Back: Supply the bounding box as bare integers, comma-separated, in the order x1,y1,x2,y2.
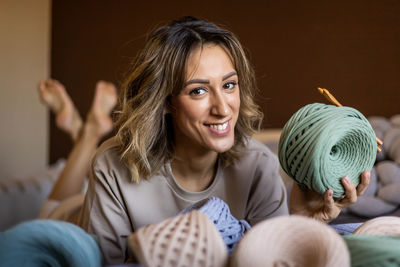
116,17,263,182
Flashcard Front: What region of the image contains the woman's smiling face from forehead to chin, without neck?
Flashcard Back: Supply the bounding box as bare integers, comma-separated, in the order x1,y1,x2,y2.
171,44,240,153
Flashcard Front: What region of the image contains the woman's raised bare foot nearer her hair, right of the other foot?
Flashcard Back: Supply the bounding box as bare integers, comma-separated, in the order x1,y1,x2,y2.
85,81,117,138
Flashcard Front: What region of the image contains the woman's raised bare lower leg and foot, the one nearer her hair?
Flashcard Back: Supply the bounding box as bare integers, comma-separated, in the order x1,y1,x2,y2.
49,81,117,201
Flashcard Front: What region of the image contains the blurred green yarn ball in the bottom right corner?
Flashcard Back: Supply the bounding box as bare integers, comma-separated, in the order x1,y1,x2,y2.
343,235,400,267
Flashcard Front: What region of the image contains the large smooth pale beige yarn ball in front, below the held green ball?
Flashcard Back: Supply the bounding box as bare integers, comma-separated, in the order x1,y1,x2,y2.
230,215,350,267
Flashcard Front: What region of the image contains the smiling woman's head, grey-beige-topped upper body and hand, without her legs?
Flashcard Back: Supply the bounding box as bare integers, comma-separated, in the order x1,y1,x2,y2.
80,17,369,263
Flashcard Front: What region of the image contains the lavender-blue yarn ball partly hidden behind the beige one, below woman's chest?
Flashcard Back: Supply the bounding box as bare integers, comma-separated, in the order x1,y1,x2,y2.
180,197,251,254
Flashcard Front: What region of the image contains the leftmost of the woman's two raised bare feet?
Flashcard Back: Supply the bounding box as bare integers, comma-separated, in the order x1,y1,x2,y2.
38,79,82,141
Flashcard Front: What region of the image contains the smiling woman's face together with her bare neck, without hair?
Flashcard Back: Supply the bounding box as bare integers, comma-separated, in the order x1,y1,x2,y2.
169,44,240,191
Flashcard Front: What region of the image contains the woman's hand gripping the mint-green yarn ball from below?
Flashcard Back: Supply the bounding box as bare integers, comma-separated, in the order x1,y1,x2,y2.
289,171,370,222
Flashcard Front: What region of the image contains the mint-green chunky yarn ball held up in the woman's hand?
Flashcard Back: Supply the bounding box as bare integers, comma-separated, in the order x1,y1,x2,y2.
278,103,377,197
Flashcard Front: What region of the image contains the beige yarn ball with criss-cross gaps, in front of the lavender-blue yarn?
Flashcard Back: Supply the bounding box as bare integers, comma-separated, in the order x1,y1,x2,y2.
127,210,228,267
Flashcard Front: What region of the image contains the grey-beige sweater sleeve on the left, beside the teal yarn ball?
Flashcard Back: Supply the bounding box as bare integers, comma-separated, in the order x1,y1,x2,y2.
78,154,133,264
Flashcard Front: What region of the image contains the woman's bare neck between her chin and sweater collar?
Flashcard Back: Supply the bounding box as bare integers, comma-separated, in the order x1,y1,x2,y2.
171,149,218,192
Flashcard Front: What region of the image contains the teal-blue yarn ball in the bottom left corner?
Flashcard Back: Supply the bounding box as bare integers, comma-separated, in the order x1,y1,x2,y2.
0,220,102,267
